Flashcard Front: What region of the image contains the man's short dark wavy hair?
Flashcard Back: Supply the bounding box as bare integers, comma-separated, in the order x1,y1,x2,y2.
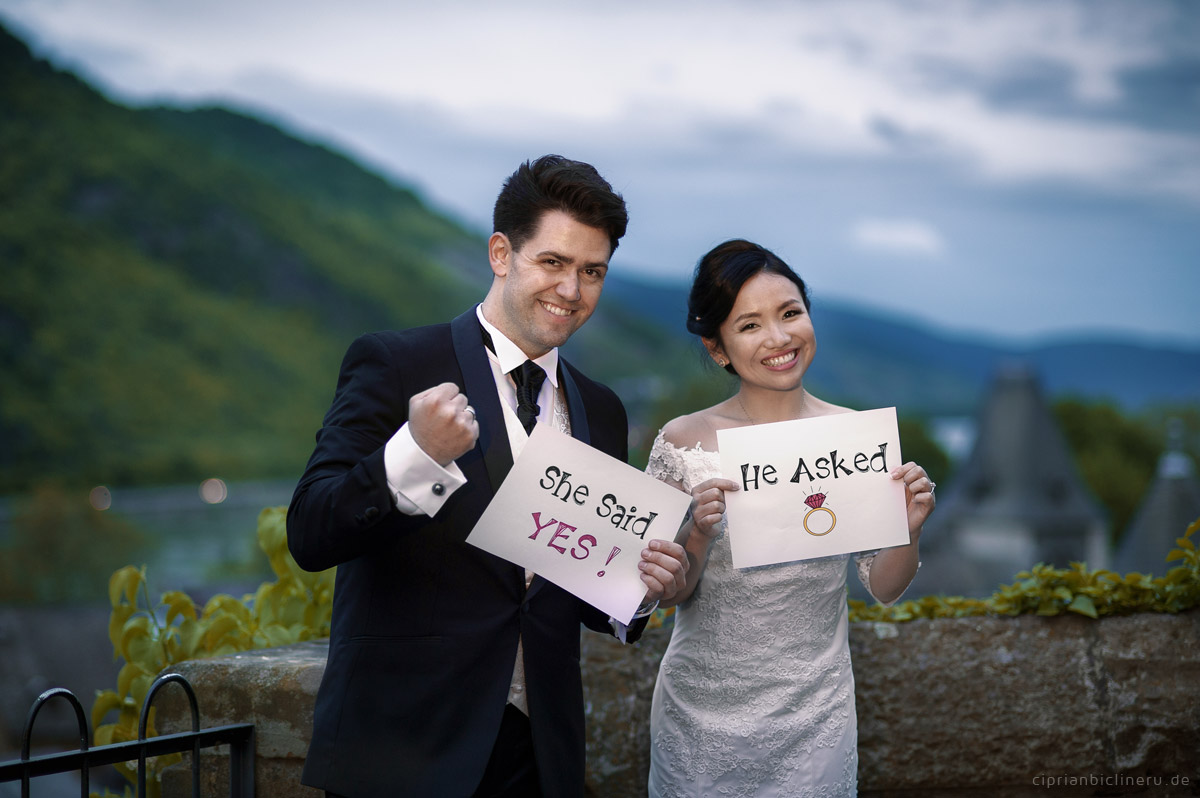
492,155,629,257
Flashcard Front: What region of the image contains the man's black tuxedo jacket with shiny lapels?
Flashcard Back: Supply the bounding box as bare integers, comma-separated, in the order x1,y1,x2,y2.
287,308,644,798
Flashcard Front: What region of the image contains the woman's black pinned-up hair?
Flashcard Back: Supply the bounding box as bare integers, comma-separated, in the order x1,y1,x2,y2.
688,239,810,374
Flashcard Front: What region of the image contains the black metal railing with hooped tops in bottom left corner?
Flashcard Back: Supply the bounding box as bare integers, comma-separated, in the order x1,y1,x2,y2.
0,673,254,798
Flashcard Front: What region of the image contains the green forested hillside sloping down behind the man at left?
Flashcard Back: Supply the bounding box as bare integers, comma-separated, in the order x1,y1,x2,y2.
0,31,486,490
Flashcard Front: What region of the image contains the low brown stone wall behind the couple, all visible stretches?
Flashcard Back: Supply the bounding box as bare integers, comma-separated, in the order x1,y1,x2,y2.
158,611,1200,798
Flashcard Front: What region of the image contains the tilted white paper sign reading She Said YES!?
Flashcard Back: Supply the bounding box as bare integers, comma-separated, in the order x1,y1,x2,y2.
467,424,691,624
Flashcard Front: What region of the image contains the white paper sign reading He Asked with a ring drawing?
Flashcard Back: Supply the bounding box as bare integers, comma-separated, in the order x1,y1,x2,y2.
716,408,908,568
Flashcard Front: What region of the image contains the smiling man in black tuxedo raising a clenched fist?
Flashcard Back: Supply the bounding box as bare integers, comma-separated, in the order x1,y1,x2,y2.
288,156,686,798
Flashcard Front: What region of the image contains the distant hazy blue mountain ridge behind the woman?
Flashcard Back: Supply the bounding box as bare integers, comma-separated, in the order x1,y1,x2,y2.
605,270,1200,415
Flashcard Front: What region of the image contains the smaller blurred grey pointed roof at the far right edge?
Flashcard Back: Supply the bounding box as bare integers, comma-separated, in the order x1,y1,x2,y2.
1114,420,1200,576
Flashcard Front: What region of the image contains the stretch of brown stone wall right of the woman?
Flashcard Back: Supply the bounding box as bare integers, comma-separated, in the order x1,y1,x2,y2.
851,612,1200,794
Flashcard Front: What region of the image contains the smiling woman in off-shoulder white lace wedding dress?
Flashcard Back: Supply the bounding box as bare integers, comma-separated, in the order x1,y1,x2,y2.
647,241,934,798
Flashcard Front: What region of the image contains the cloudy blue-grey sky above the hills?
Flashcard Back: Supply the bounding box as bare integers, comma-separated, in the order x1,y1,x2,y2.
0,0,1200,346
